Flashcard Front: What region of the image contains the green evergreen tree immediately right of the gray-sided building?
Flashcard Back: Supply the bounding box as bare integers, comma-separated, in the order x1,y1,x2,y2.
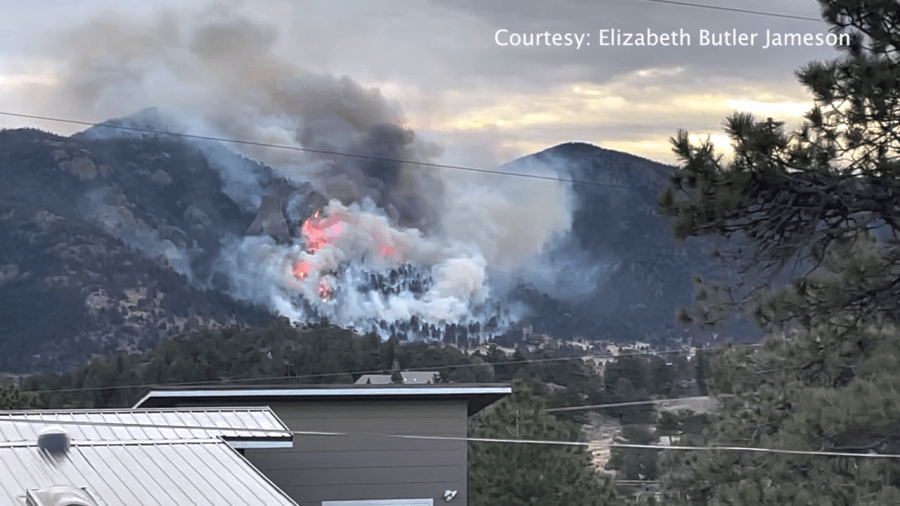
469,381,619,506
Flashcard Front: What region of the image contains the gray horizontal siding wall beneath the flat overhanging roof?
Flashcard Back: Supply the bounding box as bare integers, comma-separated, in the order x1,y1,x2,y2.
171,400,468,506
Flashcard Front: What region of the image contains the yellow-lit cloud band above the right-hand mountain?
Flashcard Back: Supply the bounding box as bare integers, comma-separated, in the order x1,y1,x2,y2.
414,67,812,163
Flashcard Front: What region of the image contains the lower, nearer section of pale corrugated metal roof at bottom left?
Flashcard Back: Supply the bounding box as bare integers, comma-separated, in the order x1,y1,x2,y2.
0,440,297,506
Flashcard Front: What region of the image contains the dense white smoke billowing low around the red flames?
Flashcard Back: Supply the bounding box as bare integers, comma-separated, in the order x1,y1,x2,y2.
221,200,536,336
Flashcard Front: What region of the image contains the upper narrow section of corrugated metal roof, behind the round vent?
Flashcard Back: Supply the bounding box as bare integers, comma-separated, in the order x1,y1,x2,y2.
0,407,291,443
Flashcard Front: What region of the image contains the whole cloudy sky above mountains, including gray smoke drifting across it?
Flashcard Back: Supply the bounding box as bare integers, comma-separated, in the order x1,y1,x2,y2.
0,0,840,166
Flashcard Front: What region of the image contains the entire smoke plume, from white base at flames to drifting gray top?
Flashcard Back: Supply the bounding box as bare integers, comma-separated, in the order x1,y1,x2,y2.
31,5,598,335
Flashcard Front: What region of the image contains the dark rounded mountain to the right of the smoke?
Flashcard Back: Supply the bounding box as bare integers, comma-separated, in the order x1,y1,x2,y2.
511,143,716,344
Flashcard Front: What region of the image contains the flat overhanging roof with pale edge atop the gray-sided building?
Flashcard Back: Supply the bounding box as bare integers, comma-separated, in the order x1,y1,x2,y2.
135,383,512,416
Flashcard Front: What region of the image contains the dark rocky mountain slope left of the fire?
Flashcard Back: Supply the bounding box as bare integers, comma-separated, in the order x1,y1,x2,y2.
0,126,280,372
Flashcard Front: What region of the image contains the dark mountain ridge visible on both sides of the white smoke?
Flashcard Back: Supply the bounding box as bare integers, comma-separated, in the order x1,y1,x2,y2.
0,123,740,372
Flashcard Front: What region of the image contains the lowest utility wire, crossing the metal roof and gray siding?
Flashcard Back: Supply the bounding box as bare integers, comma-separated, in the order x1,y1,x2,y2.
0,416,900,459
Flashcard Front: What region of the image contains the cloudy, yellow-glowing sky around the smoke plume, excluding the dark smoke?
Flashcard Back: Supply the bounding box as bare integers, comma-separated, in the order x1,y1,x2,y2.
0,0,839,168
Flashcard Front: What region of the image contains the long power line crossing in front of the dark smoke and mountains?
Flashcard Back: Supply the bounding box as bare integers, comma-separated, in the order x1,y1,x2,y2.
0,111,631,190
